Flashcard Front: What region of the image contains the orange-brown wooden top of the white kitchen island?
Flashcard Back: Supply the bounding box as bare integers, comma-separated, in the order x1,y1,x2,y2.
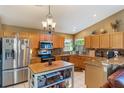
28,60,74,74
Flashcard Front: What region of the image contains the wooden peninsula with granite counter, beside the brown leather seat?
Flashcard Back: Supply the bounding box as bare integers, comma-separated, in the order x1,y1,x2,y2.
85,56,124,88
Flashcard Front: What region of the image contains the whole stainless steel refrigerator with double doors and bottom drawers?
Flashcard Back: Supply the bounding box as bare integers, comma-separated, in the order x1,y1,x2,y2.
2,38,30,87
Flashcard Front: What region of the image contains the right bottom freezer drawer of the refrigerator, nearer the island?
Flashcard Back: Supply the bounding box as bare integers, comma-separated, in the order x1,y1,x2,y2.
14,68,28,84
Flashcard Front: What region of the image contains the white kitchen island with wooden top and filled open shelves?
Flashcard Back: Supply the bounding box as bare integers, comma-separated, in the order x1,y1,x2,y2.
28,60,74,88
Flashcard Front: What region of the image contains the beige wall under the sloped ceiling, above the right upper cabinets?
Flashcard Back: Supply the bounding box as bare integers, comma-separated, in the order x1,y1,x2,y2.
75,10,124,39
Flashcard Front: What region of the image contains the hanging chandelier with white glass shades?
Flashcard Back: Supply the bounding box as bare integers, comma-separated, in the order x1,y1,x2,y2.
42,5,56,32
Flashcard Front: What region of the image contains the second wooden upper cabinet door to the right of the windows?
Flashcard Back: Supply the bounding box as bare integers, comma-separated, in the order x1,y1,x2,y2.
91,35,100,48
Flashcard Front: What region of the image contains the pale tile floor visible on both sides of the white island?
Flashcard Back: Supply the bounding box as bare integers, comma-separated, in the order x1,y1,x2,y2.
7,71,86,88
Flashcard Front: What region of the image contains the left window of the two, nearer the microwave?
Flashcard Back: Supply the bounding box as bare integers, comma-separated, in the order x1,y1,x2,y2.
64,39,73,51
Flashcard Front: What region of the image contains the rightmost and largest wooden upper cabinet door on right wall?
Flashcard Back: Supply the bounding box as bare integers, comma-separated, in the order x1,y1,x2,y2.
110,32,124,49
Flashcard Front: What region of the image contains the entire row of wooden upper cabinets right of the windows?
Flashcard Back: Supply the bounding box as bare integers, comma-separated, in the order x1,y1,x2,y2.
85,32,124,49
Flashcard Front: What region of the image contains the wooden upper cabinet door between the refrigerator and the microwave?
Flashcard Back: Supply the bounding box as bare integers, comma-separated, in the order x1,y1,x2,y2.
29,32,40,48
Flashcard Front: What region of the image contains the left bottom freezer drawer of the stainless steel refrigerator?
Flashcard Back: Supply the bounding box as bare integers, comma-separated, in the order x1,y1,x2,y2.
2,70,14,86
